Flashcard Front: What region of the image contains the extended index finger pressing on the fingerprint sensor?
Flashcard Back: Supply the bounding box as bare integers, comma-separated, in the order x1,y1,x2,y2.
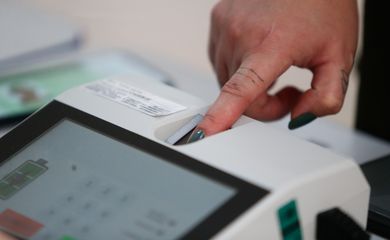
197,50,291,136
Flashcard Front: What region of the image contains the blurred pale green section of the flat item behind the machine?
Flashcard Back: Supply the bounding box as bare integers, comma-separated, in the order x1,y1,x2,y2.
0,63,105,118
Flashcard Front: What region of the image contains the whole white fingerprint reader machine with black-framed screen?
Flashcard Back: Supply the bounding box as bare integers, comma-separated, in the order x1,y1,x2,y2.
0,77,369,240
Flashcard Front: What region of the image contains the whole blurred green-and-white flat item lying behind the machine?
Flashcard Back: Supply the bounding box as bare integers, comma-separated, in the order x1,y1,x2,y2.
0,52,168,123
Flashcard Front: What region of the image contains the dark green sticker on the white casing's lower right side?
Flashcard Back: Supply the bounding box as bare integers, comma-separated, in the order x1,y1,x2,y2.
278,200,302,240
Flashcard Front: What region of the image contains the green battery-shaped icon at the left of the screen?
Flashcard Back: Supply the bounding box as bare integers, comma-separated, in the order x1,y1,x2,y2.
0,159,48,200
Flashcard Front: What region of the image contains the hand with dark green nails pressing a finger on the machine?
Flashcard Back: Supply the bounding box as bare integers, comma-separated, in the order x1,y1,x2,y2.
190,0,358,141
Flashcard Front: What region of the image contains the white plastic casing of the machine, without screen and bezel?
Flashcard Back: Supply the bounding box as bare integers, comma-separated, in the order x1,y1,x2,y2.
50,77,370,239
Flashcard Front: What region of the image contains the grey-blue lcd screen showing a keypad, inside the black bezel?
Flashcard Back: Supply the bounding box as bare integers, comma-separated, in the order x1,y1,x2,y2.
0,119,237,240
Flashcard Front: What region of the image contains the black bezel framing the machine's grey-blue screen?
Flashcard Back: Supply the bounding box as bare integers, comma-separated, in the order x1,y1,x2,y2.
0,101,269,239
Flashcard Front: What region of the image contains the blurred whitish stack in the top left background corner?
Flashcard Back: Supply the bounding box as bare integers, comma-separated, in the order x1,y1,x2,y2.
0,0,80,72
